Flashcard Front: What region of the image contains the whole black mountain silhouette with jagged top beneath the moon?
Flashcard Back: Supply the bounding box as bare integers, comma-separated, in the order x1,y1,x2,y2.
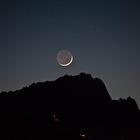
0,73,140,140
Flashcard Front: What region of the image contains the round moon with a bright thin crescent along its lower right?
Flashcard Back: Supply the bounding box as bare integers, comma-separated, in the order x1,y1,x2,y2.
56,50,73,67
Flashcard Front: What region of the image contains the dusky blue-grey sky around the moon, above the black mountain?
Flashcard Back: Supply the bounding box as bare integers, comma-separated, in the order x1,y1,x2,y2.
0,0,140,106
